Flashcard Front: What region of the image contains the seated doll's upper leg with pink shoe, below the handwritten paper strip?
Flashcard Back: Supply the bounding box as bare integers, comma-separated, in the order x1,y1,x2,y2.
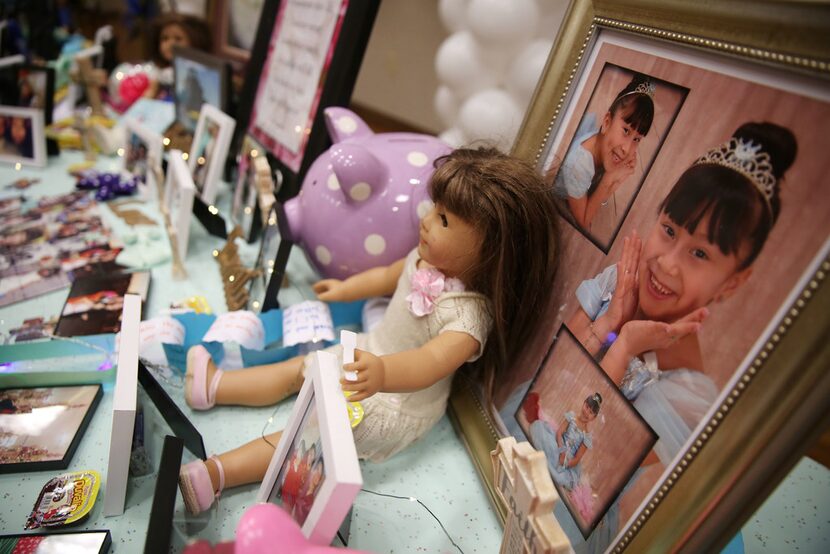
184,346,303,410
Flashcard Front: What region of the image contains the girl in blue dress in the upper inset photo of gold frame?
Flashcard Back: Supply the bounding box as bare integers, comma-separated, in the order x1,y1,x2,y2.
554,73,654,230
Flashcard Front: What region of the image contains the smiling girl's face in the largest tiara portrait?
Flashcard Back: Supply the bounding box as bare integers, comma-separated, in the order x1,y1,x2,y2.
637,213,751,322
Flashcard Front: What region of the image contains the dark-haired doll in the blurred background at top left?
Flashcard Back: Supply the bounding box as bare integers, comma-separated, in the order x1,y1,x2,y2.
144,13,212,99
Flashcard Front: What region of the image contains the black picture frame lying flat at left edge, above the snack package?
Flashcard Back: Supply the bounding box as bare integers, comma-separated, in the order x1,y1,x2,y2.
0,383,103,474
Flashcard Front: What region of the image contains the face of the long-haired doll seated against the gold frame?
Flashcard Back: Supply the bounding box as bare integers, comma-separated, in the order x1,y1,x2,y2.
418,204,482,281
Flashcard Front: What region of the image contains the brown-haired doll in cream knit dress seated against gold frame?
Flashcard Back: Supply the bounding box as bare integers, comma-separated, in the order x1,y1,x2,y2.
179,148,558,513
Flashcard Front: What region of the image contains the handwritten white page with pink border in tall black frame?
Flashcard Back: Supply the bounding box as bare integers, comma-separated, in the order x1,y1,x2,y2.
254,0,345,164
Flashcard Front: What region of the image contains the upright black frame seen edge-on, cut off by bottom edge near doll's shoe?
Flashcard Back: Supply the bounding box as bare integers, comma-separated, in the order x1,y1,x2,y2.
146,436,184,552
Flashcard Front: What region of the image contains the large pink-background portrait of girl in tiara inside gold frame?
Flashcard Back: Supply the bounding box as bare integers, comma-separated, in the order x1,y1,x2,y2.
494,36,830,552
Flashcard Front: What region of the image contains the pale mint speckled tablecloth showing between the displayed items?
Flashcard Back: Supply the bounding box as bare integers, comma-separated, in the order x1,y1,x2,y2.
0,152,830,553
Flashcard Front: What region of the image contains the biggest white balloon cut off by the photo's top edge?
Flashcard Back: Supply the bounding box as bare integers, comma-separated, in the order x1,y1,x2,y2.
467,0,539,44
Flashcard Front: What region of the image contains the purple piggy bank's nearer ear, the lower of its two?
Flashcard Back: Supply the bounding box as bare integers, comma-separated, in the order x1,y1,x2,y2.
330,142,389,204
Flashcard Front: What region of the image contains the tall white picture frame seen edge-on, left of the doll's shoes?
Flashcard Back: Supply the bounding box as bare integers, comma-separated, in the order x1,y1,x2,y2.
104,294,141,516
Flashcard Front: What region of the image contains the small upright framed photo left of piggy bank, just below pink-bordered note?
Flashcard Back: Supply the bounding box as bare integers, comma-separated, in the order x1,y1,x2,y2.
231,137,276,242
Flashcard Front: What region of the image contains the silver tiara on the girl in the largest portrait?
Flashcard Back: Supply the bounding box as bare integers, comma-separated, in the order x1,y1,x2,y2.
692,137,778,213
